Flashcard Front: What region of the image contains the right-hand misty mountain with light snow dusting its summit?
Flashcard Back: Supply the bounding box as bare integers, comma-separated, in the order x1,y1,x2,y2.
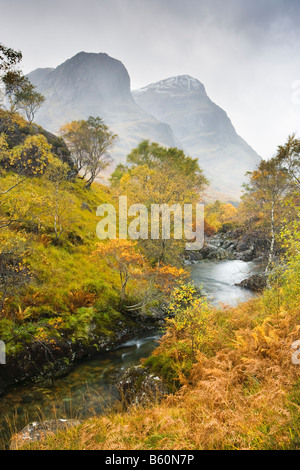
133,75,260,200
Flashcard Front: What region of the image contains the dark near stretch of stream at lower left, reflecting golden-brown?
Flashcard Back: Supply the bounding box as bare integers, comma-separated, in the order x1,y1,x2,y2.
0,331,160,445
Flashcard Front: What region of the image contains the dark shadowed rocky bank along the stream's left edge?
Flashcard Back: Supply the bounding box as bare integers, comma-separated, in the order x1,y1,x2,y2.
0,310,165,396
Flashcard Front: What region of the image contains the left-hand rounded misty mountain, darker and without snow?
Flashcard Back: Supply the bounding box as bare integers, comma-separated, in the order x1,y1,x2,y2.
28,52,175,160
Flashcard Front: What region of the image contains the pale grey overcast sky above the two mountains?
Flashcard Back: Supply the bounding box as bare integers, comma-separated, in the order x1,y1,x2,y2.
0,0,300,158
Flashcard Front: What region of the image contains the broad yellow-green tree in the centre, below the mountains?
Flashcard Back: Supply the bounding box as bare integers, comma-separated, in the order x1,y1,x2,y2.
111,141,207,264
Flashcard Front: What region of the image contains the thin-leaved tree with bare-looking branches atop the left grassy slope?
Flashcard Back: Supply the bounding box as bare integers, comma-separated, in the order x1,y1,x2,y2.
61,116,117,188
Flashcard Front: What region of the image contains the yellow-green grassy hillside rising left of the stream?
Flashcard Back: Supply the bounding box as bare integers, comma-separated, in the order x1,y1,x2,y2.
0,111,157,391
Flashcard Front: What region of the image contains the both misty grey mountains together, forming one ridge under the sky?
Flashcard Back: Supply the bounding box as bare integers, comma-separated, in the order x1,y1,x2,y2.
28,52,260,200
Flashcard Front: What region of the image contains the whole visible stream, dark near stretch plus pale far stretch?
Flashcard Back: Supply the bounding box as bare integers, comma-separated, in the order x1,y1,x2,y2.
0,261,258,446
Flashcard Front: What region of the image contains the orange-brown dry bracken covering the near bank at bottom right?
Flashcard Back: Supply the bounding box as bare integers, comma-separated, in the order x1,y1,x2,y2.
18,301,300,450
